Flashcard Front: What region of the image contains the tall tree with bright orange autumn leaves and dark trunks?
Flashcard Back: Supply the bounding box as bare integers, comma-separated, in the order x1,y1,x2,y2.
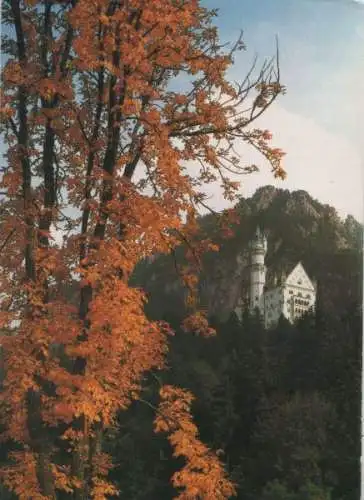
0,0,284,500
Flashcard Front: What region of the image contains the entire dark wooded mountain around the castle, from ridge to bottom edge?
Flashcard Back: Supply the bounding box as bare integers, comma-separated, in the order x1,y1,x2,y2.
121,186,363,500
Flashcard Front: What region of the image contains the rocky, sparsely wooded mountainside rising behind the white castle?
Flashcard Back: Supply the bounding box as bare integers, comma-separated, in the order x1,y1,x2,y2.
133,186,363,319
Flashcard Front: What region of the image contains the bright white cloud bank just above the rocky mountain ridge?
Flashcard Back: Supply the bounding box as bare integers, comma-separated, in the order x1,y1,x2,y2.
200,104,363,221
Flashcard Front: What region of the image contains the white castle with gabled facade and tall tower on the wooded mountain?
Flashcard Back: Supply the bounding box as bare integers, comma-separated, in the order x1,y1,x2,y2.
236,227,316,328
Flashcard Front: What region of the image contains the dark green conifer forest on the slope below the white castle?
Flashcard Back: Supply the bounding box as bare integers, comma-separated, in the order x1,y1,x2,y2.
106,306,362,500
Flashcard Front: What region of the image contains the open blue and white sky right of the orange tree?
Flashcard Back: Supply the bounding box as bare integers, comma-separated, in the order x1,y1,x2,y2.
202,0,364,222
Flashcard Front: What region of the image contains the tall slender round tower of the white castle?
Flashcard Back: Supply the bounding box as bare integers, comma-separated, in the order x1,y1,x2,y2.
249,227,267,313
